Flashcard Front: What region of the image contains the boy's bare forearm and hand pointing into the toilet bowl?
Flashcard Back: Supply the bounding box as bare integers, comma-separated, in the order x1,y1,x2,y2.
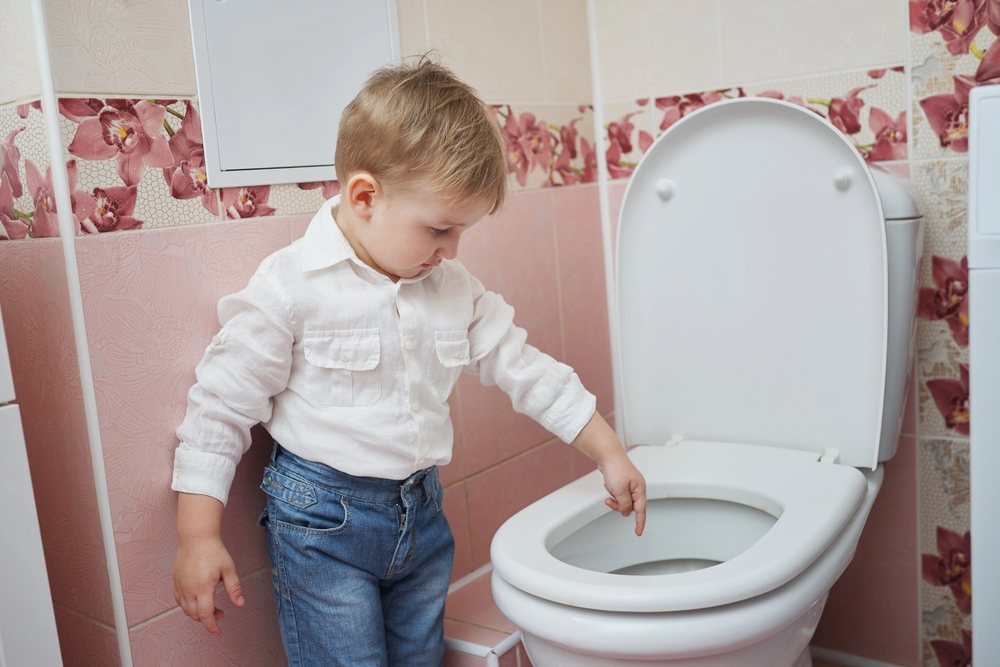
570,412,646,535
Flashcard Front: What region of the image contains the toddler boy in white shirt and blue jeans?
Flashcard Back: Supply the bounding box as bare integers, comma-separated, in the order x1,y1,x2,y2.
172,59,646,667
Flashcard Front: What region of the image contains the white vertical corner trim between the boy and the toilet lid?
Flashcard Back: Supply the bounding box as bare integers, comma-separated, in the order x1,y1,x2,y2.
587,0,629,447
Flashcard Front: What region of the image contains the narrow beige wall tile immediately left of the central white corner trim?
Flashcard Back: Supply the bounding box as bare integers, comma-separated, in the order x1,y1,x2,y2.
538,0,593,104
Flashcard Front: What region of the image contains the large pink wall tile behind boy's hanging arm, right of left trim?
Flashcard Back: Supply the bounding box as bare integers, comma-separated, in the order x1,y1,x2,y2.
77,218,289,625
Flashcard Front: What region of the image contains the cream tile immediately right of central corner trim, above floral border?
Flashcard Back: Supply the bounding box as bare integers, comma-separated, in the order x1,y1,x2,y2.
597,0,722,101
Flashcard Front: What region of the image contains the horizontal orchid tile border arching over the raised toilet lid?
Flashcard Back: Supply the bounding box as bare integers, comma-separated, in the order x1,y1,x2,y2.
604,65,909,178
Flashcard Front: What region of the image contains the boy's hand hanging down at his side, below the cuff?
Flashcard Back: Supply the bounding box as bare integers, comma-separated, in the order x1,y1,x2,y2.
174,493,244,636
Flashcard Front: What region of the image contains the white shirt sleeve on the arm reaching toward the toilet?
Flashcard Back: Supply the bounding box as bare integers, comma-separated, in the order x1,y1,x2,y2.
466,276,597,443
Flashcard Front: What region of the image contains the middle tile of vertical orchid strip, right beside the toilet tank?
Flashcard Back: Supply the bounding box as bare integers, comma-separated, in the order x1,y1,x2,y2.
912,158,969,437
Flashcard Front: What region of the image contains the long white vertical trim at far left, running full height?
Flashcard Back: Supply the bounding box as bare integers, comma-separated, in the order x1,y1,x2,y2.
31,0,132,667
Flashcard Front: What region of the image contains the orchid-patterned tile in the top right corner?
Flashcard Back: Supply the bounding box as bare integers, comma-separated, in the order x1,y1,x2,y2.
909,0,1000,158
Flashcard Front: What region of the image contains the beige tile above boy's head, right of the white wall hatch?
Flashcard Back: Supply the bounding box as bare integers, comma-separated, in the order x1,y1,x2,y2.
425,0,545,104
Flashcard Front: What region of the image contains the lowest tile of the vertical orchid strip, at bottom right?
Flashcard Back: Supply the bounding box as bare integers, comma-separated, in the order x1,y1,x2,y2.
919,438,972,667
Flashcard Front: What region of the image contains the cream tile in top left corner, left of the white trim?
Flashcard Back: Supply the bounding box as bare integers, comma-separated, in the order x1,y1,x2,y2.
0,0,42,104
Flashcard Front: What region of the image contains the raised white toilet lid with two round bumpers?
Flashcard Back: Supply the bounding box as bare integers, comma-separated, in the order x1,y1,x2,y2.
617,98,887,468
